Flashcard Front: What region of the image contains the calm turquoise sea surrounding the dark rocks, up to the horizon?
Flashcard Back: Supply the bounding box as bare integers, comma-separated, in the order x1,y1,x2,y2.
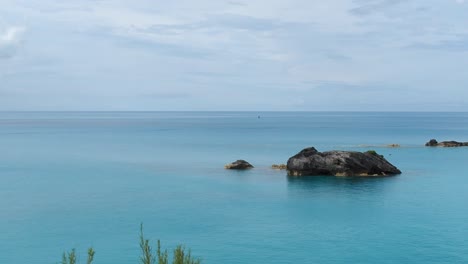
0,112,468,264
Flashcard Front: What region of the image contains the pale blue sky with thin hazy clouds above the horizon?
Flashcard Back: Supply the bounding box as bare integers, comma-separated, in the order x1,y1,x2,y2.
0,0,468,111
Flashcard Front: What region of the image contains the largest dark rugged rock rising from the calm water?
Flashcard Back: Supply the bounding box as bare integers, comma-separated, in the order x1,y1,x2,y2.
287,147,401,176
